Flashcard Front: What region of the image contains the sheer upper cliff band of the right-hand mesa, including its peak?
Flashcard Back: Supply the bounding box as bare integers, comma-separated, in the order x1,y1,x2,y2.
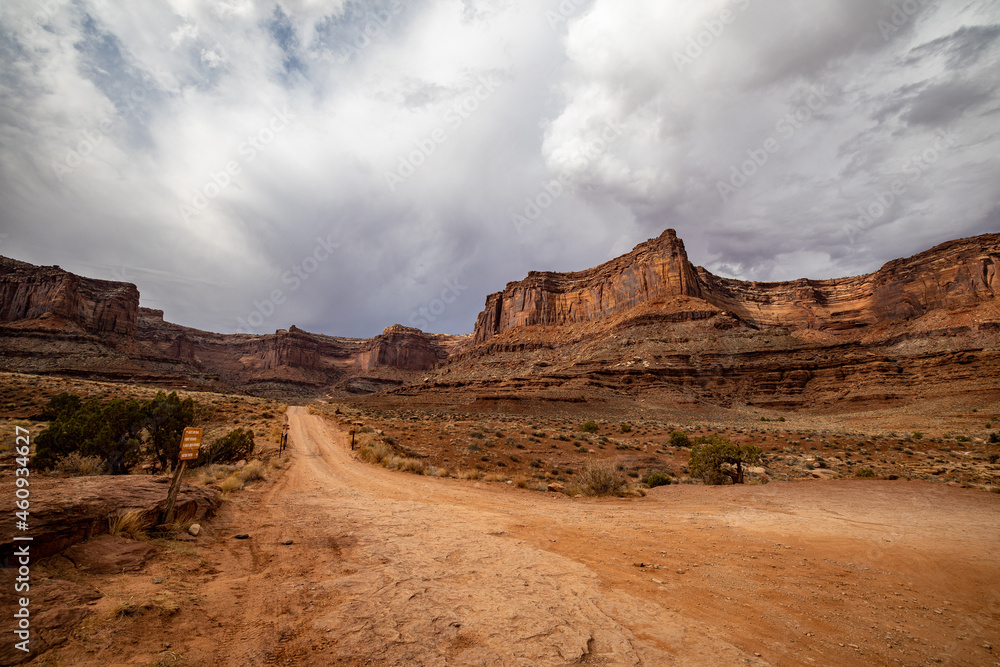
475,229,1000,344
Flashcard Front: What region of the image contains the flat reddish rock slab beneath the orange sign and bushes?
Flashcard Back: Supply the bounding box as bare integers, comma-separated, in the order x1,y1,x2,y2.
0,475,220,567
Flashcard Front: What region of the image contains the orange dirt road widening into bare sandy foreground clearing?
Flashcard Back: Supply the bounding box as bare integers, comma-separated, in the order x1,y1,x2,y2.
42,407,1000,666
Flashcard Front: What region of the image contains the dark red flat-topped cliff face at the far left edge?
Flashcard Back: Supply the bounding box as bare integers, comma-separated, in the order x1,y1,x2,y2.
0,258,139,336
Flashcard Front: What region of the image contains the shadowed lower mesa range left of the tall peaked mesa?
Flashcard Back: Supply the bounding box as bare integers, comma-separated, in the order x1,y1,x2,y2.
0,258,467,393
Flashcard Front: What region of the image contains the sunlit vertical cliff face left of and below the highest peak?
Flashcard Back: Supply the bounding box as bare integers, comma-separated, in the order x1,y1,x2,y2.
474,229,700,343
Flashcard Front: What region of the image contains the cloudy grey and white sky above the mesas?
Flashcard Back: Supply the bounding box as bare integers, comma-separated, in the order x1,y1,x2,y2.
0,0,1000,336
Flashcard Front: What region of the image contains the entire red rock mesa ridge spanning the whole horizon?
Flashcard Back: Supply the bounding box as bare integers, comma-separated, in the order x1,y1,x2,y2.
0,230,1000,409
